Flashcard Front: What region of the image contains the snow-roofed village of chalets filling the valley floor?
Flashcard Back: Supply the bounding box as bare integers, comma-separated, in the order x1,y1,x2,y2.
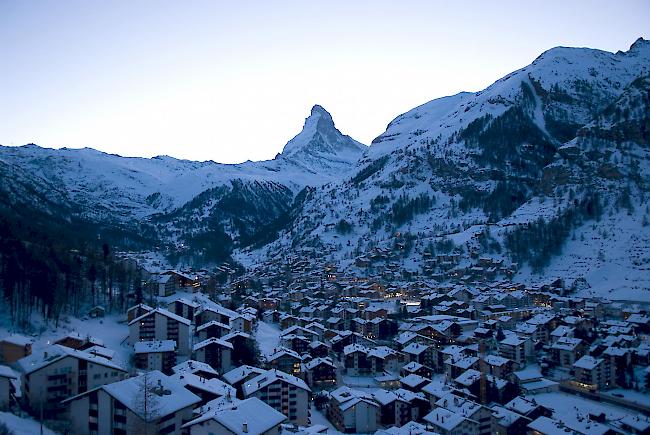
0,252,650,435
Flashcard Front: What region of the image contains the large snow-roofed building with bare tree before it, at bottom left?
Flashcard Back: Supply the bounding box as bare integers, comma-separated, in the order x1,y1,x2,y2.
64,371,201,435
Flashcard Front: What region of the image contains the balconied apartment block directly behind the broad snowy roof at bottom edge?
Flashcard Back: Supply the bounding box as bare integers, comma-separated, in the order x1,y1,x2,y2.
242,370,311,426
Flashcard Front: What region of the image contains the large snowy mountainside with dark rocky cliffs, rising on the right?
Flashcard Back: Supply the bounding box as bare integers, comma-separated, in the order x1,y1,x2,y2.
251,39,650,300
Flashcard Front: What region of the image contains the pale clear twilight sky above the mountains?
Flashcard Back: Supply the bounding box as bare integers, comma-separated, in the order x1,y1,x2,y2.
0,0,650,163
